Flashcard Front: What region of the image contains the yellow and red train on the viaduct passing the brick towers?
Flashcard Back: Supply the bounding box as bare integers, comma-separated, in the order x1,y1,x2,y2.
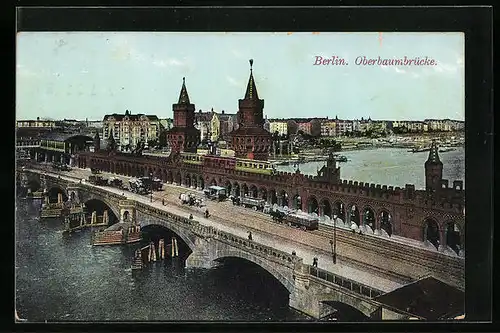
181,152,276,175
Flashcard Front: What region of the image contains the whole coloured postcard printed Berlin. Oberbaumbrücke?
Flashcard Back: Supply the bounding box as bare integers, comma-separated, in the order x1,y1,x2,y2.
15,31,467,322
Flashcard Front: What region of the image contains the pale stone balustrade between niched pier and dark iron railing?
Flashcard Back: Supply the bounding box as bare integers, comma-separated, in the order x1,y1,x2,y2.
136,201,302,268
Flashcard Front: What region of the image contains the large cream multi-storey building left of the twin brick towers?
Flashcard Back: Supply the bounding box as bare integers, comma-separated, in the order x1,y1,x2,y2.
102,110,160,151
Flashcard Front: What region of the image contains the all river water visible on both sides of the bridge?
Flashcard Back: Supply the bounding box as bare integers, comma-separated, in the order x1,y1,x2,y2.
15,149,465,322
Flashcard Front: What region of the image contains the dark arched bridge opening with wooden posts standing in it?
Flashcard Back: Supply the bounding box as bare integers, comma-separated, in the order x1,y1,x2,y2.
140,224,192,268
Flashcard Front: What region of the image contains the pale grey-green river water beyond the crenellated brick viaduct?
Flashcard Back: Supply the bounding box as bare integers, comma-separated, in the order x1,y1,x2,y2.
276,148,465,190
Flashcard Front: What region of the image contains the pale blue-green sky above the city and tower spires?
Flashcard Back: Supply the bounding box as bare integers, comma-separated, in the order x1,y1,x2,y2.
16,32,465,120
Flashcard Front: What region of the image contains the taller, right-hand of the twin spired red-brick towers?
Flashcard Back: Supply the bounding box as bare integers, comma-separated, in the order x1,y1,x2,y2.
230,60,271,161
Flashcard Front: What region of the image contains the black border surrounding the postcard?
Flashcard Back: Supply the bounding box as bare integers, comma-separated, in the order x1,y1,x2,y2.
6,5,493,332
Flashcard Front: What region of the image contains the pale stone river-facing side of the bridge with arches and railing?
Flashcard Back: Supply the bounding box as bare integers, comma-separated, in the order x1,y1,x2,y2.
20,170,406,319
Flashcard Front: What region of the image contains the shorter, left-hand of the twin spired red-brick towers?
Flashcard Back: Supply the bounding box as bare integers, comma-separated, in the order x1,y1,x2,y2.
166,78,200,153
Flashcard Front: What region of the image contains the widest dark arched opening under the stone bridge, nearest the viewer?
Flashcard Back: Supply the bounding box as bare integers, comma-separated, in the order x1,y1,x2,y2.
211,257,289,312
